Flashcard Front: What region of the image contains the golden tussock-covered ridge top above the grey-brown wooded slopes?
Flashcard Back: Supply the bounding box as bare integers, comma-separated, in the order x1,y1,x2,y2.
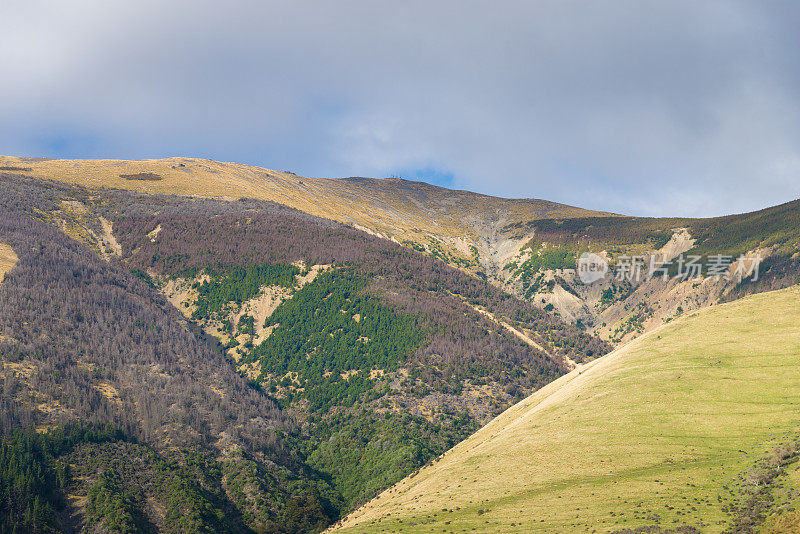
0,156,611,278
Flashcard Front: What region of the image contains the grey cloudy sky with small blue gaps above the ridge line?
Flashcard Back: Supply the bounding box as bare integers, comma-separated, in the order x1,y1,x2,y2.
0,0,800,216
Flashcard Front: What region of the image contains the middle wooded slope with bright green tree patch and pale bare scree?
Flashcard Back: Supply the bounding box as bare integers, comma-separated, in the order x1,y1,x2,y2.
89,176,607,505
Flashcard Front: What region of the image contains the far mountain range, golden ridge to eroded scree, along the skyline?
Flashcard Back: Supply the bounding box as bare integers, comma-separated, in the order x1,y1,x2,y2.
0,157,800,350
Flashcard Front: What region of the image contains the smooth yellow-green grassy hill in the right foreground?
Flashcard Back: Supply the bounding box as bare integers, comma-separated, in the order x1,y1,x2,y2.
334,287,800,532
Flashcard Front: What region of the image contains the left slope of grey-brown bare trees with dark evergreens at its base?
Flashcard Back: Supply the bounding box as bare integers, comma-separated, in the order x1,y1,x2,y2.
0,177,338,532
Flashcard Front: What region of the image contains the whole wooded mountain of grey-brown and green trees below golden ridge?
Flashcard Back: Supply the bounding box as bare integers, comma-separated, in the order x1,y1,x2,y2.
0,171,609,532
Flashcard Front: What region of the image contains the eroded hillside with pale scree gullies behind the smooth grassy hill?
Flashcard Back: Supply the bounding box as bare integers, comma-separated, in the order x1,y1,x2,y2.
498,205,800,344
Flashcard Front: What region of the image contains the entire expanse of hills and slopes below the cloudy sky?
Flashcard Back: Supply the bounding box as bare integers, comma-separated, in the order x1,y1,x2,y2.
0,163,800,532
